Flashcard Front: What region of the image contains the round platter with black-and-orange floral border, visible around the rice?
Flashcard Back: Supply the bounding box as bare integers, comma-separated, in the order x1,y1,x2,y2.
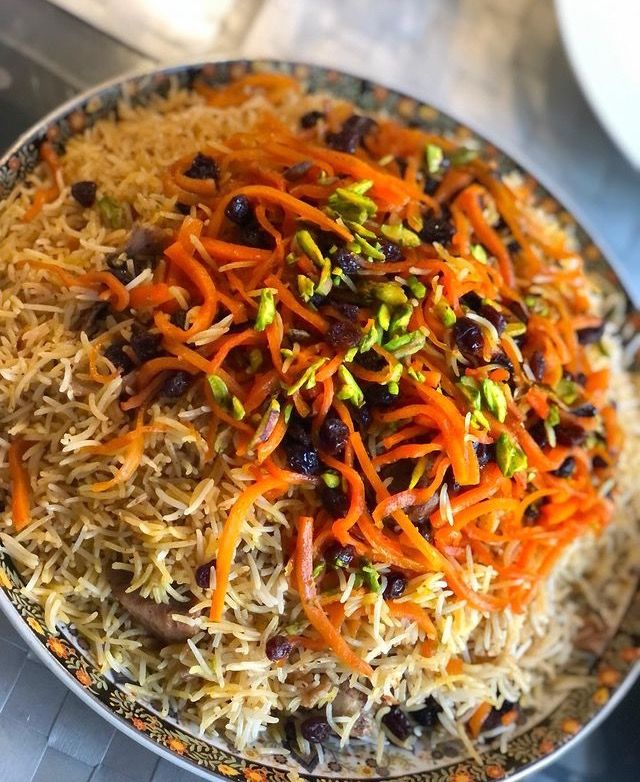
0,61,640,782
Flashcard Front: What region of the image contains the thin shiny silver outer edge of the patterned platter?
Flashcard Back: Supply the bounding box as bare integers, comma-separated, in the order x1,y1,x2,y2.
0,57,640,782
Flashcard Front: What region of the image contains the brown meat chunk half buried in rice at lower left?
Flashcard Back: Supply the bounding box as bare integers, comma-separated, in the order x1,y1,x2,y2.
109,570,197,646
